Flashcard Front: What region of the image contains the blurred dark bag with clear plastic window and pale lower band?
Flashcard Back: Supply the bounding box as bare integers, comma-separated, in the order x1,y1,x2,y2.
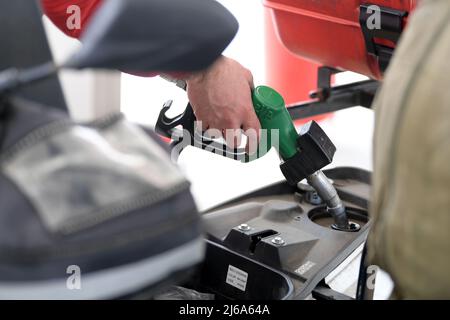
0,99,204,299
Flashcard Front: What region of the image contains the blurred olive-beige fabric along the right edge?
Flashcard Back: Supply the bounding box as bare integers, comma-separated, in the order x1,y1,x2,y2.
369,0,450,298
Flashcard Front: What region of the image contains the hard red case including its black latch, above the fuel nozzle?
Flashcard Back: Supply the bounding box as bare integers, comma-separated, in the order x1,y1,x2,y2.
264,0,417,79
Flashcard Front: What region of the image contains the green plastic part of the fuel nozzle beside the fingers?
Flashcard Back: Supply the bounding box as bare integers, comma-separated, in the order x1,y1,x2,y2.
252,86,298,160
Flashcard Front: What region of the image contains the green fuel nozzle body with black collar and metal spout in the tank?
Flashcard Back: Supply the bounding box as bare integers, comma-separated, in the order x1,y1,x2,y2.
252,86,355,231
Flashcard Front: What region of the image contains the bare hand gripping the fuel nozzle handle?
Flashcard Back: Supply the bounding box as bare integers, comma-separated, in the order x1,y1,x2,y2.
186,56,261,153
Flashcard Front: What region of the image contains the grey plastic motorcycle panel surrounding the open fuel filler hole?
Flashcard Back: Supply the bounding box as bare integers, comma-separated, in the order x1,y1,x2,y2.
203,168,371,299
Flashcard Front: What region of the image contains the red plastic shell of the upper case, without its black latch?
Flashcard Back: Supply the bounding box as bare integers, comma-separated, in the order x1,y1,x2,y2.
264,0,417,79
